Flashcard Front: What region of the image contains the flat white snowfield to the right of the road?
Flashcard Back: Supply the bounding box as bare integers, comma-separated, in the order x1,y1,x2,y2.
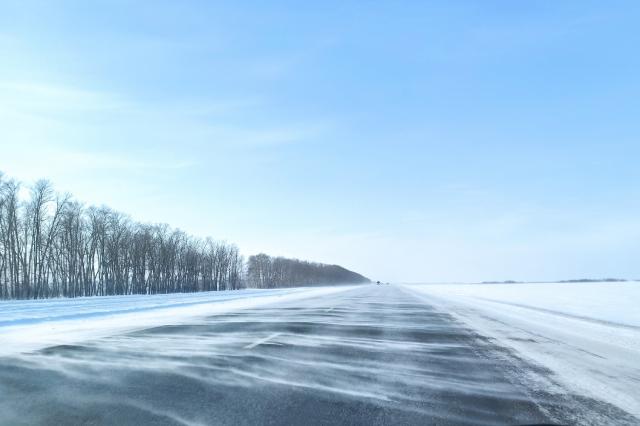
405,282,640,417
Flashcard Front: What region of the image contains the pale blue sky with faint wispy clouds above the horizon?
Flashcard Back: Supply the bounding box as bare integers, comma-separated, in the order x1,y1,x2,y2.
0,1,640,281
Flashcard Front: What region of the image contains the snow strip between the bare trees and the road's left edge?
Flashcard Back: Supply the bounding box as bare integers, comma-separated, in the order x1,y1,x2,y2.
0,286,352,356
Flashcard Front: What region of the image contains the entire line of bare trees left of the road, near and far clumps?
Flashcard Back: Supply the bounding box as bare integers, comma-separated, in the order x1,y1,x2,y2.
0,174,362,299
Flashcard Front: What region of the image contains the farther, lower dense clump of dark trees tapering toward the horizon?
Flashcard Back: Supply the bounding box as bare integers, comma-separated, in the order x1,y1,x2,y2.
247,254,369,288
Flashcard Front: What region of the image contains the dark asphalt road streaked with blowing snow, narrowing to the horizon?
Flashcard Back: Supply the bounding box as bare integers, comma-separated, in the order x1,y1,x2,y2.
0,285,635,426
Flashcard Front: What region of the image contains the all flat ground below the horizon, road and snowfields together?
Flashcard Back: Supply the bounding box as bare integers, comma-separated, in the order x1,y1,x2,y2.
0,283,640,426
